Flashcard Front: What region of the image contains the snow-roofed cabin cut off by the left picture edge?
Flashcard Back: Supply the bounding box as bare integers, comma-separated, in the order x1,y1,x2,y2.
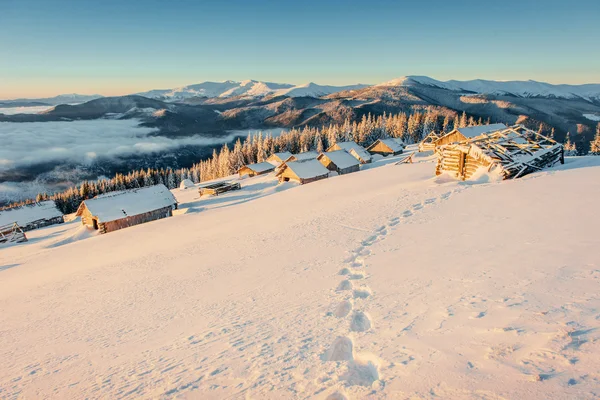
0,200,65,232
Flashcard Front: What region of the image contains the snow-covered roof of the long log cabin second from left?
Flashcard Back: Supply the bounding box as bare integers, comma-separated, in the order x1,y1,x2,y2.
77,184,177,222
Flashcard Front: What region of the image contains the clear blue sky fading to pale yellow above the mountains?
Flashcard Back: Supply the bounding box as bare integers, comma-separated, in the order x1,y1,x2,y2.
0,0,600,98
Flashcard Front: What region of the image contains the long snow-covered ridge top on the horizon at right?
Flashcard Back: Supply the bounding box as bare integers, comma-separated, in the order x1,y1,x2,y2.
377,76,600,100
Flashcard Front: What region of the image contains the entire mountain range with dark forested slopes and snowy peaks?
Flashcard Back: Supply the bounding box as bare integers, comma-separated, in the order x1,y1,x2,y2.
0,76,600,141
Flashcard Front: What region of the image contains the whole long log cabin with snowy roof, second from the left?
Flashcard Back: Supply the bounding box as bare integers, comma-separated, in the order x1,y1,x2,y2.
76,184,177,233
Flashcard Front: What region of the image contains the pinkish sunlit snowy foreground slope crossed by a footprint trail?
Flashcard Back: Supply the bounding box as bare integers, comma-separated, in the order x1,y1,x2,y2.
0,155,600,399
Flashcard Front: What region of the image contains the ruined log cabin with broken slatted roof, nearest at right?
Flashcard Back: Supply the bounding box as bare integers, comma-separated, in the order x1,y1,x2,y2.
436,125,564,180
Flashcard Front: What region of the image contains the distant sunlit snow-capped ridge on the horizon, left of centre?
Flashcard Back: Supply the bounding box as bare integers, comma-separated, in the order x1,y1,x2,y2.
137,80,367,100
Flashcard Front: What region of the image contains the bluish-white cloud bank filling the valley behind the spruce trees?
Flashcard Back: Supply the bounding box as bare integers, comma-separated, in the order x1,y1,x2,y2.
0,119,281,203
